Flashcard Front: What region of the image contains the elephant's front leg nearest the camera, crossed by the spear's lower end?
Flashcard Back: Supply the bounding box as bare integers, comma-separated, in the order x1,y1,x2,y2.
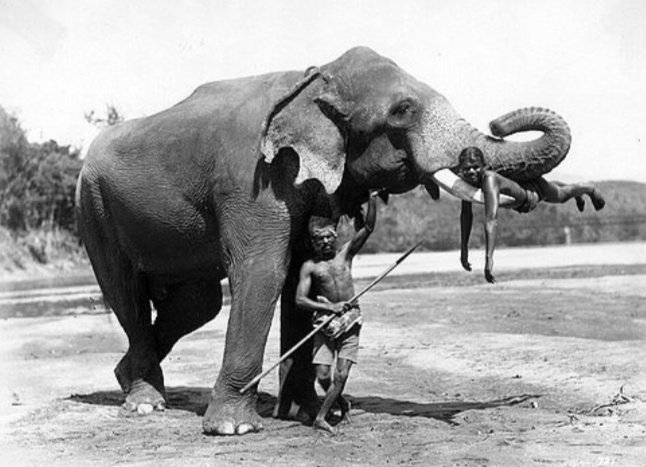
203,254,286,435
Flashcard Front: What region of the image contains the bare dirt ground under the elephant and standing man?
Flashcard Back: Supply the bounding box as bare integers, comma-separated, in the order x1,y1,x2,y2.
0,265,646,466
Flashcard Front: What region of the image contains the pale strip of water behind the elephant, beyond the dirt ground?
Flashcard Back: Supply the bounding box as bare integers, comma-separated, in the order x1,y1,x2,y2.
0,242,646,319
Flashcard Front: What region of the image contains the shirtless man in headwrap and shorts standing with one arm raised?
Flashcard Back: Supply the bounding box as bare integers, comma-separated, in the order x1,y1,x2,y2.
296,191,378,434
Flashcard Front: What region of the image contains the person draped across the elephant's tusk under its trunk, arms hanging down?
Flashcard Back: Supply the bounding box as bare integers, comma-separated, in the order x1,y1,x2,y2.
458,147,606,284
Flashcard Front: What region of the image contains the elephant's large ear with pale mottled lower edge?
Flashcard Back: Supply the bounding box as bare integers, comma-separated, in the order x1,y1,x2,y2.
260,68,345,193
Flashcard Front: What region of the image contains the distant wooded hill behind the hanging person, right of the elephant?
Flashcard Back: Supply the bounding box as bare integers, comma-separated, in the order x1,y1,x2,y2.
350,181,646,252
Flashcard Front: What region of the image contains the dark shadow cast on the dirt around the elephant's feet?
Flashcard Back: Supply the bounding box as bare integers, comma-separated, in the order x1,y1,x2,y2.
68,386,540,424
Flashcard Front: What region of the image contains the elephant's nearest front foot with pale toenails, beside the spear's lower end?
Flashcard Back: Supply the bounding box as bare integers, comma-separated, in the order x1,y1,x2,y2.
202,389,263,436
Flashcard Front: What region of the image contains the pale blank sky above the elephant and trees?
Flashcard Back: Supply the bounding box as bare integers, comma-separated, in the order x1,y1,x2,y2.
0,0,646,182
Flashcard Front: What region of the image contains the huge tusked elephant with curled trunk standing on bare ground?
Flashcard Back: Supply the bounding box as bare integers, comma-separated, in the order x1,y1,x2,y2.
76,47,569,435
